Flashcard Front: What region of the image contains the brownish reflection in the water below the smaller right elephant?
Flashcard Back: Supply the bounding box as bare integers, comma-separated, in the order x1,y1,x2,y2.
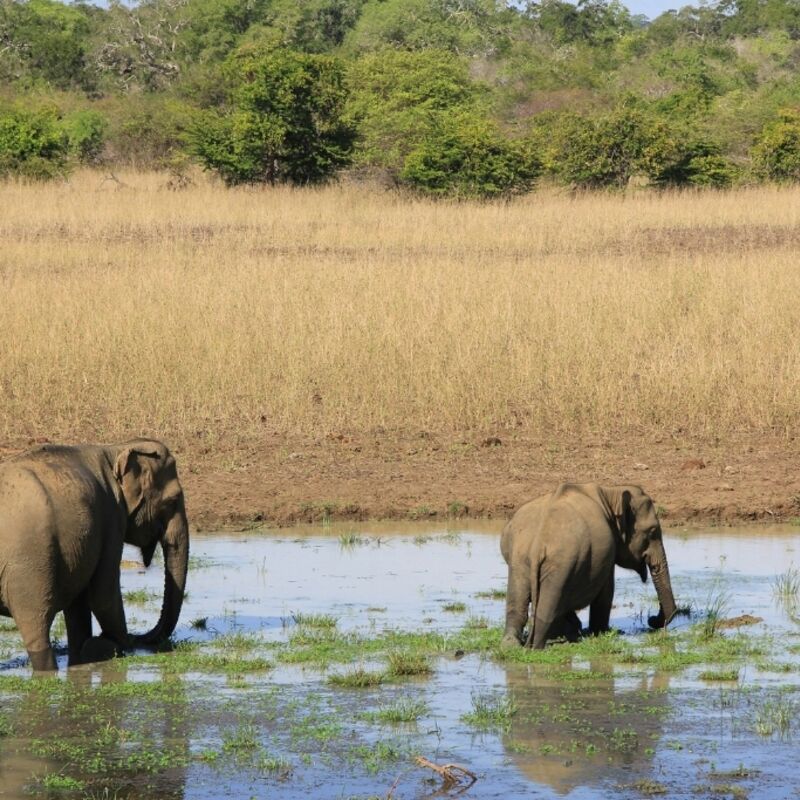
503,663,669,795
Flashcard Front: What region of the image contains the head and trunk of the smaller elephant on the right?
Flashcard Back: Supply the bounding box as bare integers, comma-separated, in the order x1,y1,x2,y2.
610,486,677,628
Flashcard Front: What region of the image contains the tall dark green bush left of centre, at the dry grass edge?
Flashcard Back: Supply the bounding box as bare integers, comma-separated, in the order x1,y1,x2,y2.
188,51,355,185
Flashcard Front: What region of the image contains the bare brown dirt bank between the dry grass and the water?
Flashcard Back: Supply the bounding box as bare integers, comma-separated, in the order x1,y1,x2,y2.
0,431,800,531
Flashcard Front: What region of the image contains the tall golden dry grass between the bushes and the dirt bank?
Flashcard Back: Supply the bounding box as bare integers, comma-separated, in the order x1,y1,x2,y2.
0,173,800,438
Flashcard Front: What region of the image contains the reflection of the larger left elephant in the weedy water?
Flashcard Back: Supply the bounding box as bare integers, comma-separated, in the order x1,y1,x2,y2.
0,662,190,800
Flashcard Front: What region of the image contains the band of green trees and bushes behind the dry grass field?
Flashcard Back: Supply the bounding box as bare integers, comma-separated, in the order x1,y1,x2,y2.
0,0,800,197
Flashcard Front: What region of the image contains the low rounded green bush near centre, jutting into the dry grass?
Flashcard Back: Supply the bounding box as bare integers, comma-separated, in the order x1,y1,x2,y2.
400,114,541,198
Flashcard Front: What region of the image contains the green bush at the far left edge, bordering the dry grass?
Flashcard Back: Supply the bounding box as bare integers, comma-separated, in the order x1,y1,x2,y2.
0,111,69,180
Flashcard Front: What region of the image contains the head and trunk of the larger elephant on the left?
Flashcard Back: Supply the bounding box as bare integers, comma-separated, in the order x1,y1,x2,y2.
114,439,189,644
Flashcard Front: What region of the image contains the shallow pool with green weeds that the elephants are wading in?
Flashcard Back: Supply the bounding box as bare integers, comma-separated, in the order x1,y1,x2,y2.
0,522,800,800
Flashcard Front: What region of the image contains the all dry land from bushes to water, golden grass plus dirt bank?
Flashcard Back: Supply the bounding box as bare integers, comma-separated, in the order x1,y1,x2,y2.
0,172,800,524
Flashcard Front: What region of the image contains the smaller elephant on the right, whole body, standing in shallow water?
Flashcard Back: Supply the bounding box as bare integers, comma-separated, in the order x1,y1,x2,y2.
500,483,677,649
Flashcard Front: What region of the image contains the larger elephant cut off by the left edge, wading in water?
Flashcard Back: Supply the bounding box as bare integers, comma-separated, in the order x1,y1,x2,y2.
0,439,189,672
